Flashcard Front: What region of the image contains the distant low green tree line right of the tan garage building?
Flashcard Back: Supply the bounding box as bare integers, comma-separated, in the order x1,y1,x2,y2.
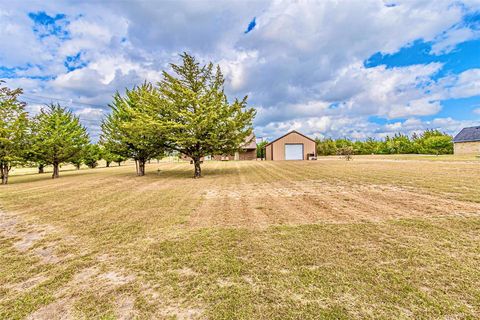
316,130,453,156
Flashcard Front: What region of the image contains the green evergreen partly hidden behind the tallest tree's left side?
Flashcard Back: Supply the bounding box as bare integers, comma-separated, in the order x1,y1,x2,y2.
100,83,165,176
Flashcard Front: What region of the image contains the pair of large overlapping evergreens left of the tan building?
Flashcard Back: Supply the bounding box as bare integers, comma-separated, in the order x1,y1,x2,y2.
100,53,255,178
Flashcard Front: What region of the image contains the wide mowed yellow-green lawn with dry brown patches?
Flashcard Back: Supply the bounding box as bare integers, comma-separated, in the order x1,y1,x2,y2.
0,156,480,319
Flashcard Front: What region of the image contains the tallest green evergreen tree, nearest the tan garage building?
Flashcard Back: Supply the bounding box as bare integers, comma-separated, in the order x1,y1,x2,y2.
156,53,255,178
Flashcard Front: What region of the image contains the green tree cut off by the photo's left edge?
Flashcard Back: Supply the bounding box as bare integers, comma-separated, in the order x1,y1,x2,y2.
0,80,28,184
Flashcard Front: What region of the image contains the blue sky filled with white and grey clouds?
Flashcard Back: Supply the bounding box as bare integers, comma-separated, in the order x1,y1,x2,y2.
0,0,480,139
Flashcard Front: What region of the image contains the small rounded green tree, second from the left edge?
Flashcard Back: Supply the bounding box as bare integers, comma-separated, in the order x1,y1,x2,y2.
32,104,89,178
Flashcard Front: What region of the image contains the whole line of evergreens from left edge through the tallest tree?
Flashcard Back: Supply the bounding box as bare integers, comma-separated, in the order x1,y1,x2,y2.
0,53,255,184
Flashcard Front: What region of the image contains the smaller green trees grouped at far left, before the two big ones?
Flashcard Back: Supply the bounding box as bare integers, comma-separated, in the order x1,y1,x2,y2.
0,82,113,184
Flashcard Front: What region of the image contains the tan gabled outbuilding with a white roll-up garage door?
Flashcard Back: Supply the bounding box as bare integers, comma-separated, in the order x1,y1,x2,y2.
265,131,317,160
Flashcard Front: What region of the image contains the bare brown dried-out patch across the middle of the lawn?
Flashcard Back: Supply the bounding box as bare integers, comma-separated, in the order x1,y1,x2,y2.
189,180,480,228
